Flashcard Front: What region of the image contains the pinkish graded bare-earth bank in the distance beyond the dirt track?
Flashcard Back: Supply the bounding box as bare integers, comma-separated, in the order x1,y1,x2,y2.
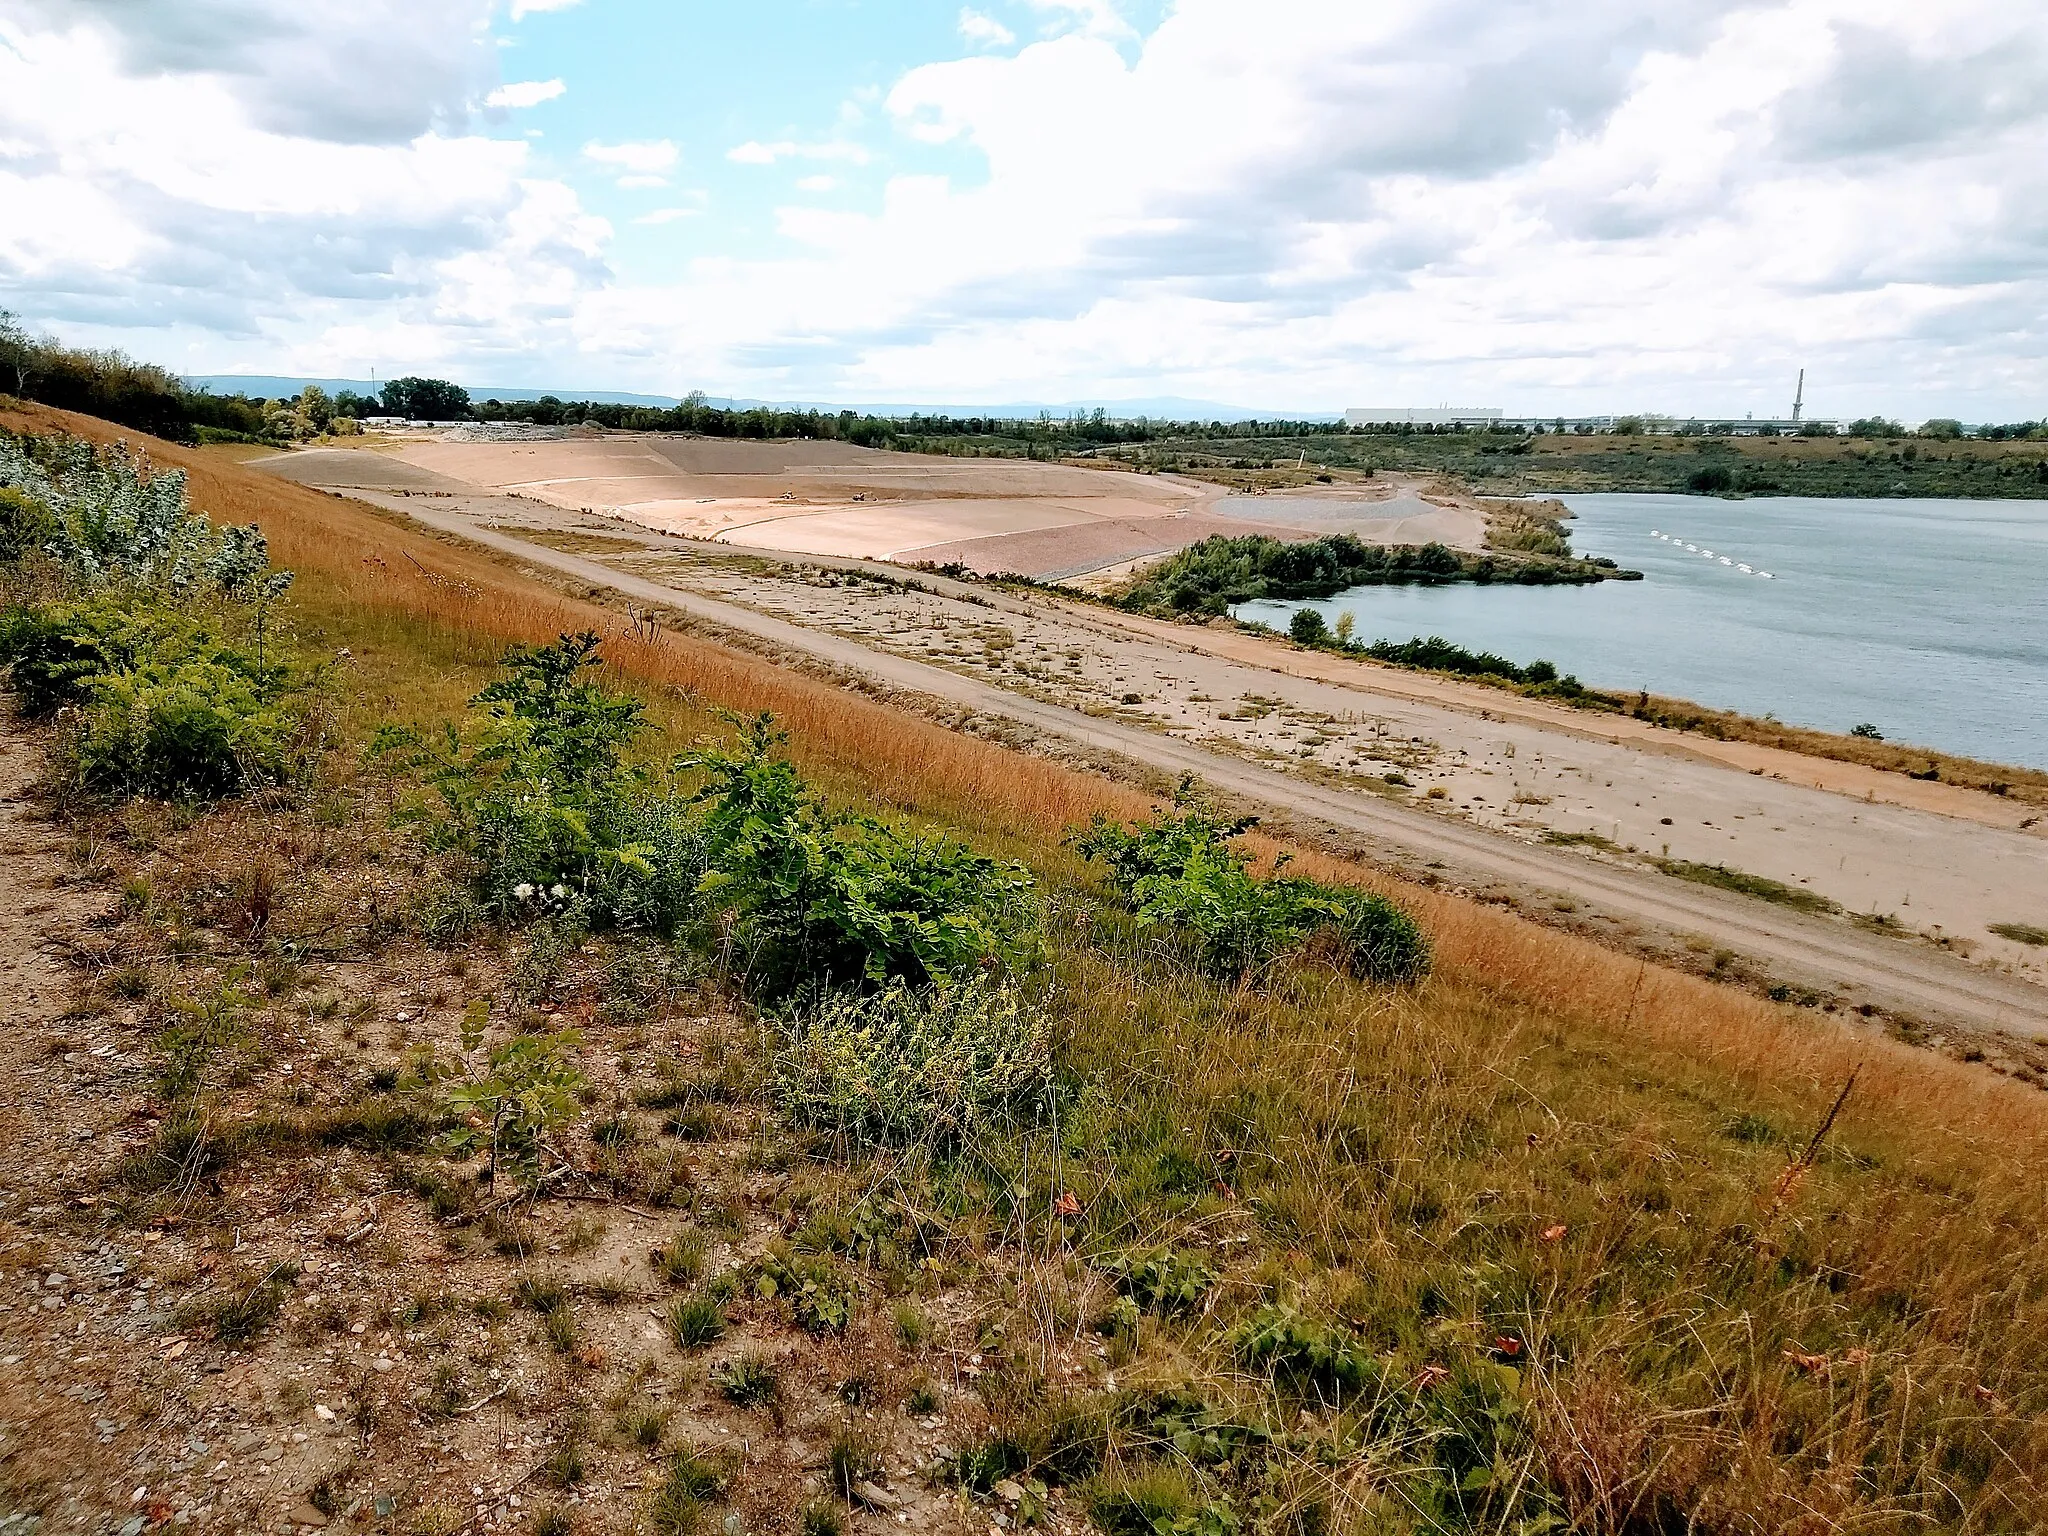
270,434,1485,580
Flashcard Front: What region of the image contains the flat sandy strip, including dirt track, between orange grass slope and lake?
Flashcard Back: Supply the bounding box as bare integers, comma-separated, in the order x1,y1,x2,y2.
251,455,2048,1036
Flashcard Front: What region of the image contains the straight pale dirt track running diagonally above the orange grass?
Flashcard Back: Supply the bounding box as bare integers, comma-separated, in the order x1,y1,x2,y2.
387,502,2048,1038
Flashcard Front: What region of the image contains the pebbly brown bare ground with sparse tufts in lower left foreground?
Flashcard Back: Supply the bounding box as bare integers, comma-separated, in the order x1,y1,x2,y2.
0,725,1102,1536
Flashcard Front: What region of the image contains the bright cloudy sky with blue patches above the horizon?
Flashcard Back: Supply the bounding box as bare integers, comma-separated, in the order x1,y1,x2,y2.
0,0,2048,420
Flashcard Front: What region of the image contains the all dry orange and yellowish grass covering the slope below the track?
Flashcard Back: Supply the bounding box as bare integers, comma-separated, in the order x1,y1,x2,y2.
12,399,2048,1536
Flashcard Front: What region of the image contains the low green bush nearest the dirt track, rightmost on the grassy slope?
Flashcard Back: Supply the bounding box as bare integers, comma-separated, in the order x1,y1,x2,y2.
1077,782,1430,983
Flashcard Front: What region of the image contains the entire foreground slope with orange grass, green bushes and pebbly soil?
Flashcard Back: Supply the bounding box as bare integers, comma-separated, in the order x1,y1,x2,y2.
0,418,2048,1536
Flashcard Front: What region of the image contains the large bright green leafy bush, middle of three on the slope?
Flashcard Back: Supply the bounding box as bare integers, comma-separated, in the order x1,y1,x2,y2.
688,715,1032,995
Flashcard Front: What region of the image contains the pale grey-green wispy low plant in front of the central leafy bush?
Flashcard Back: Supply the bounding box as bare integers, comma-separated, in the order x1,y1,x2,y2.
776,979,1055,1143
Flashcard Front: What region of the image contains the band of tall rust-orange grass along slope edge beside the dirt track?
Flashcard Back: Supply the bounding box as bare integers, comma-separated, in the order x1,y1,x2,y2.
16,408,2048,1161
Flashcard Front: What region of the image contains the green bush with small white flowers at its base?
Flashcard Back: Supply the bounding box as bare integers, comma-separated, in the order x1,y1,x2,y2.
373,631,705,936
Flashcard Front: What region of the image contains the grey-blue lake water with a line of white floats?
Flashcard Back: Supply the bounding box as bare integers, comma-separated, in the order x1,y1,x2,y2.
1239,496,2048,768
